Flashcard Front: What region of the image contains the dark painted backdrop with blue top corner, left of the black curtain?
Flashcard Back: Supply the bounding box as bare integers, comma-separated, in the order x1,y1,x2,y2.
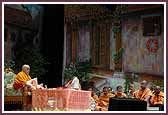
4,4,46,81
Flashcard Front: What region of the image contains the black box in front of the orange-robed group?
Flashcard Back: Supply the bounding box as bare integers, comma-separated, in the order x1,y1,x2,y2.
108,98,147,111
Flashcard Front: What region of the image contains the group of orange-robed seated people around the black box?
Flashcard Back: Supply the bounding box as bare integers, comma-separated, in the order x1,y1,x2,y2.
88,80,164,111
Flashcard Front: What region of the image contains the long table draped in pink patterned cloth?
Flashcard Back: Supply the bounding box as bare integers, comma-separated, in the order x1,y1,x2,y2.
32,88,91,111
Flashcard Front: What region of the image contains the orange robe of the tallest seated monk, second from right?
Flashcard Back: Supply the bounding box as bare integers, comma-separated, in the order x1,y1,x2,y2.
134,88,152,101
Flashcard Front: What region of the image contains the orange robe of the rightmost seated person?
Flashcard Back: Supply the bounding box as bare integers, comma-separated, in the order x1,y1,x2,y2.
150,92,164,105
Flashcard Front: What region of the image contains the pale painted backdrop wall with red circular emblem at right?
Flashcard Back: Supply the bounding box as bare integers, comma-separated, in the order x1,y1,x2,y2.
122,16,164,75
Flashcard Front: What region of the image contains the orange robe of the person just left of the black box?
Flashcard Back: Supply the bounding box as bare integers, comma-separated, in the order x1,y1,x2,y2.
96,93,115,111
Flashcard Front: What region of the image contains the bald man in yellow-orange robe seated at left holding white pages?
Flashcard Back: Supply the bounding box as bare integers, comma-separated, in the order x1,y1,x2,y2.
13,65,43,90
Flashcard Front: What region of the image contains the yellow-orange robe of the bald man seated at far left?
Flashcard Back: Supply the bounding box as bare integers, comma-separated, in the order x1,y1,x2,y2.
14,71,31,90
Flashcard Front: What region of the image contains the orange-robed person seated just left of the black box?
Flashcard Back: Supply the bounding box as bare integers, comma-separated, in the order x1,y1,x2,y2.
96,87,115,111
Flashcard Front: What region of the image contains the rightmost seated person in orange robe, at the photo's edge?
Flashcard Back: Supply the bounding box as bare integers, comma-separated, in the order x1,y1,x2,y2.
150,86,164,107
